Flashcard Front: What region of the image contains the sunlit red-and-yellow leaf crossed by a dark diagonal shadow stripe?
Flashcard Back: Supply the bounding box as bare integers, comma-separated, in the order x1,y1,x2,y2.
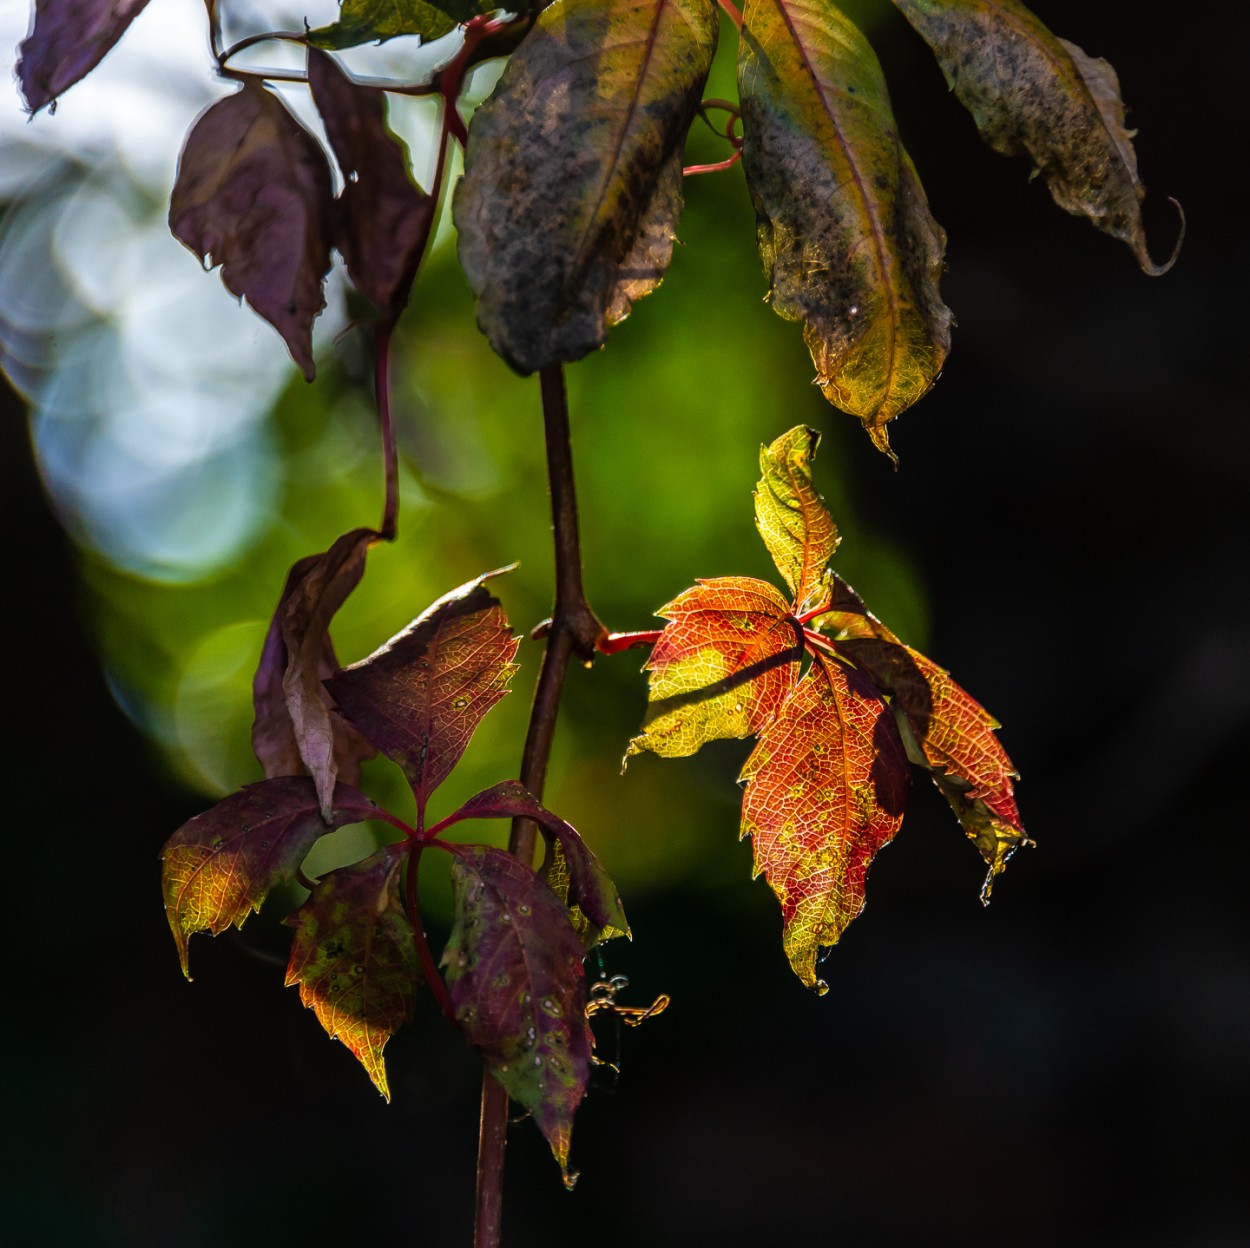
625,576,803,758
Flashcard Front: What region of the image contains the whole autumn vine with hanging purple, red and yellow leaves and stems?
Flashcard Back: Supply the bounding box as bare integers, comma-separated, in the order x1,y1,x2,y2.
19,0,1184,1248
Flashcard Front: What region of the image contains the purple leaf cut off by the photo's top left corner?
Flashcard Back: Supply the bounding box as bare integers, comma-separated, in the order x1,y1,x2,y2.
18,0,148,113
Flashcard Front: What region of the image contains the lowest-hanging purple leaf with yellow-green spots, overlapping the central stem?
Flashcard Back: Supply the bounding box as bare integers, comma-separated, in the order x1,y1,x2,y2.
443,845,593,1183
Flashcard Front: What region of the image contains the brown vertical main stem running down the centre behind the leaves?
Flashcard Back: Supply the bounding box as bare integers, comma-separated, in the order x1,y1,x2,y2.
474,364,606,1248
